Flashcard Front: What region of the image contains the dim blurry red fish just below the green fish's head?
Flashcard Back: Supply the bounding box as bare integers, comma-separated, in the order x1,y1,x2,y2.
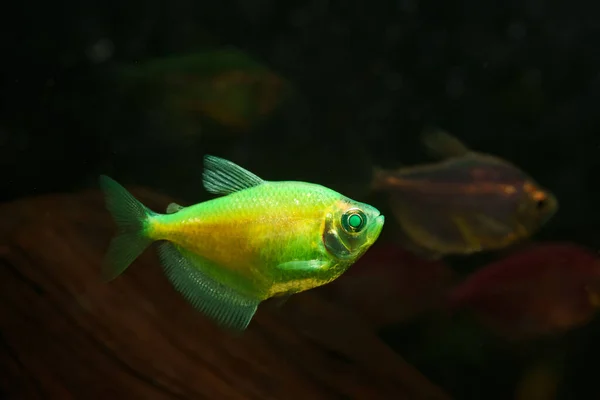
330,242,453,328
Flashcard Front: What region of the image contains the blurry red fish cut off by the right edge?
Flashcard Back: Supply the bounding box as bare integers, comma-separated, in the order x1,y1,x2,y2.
449,242,600,338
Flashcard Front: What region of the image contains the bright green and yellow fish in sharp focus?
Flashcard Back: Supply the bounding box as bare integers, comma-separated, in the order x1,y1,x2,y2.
100,156,384,330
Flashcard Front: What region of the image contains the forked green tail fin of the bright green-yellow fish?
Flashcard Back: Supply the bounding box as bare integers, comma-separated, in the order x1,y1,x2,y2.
99,175,155,281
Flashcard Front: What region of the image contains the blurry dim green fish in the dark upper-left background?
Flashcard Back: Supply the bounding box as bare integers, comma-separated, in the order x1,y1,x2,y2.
118,48,291,133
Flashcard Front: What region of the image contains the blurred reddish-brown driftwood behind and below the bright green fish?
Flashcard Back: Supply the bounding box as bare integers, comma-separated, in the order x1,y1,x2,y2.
0,189,449,400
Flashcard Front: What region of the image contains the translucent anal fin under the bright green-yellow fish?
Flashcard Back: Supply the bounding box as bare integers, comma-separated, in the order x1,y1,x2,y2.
158,242,260,332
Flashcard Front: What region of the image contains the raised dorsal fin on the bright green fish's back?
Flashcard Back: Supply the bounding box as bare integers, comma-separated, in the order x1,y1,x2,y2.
203,155,265,194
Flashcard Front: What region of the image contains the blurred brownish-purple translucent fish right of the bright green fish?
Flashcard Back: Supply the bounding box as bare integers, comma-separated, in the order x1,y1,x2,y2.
372,131,558,258
